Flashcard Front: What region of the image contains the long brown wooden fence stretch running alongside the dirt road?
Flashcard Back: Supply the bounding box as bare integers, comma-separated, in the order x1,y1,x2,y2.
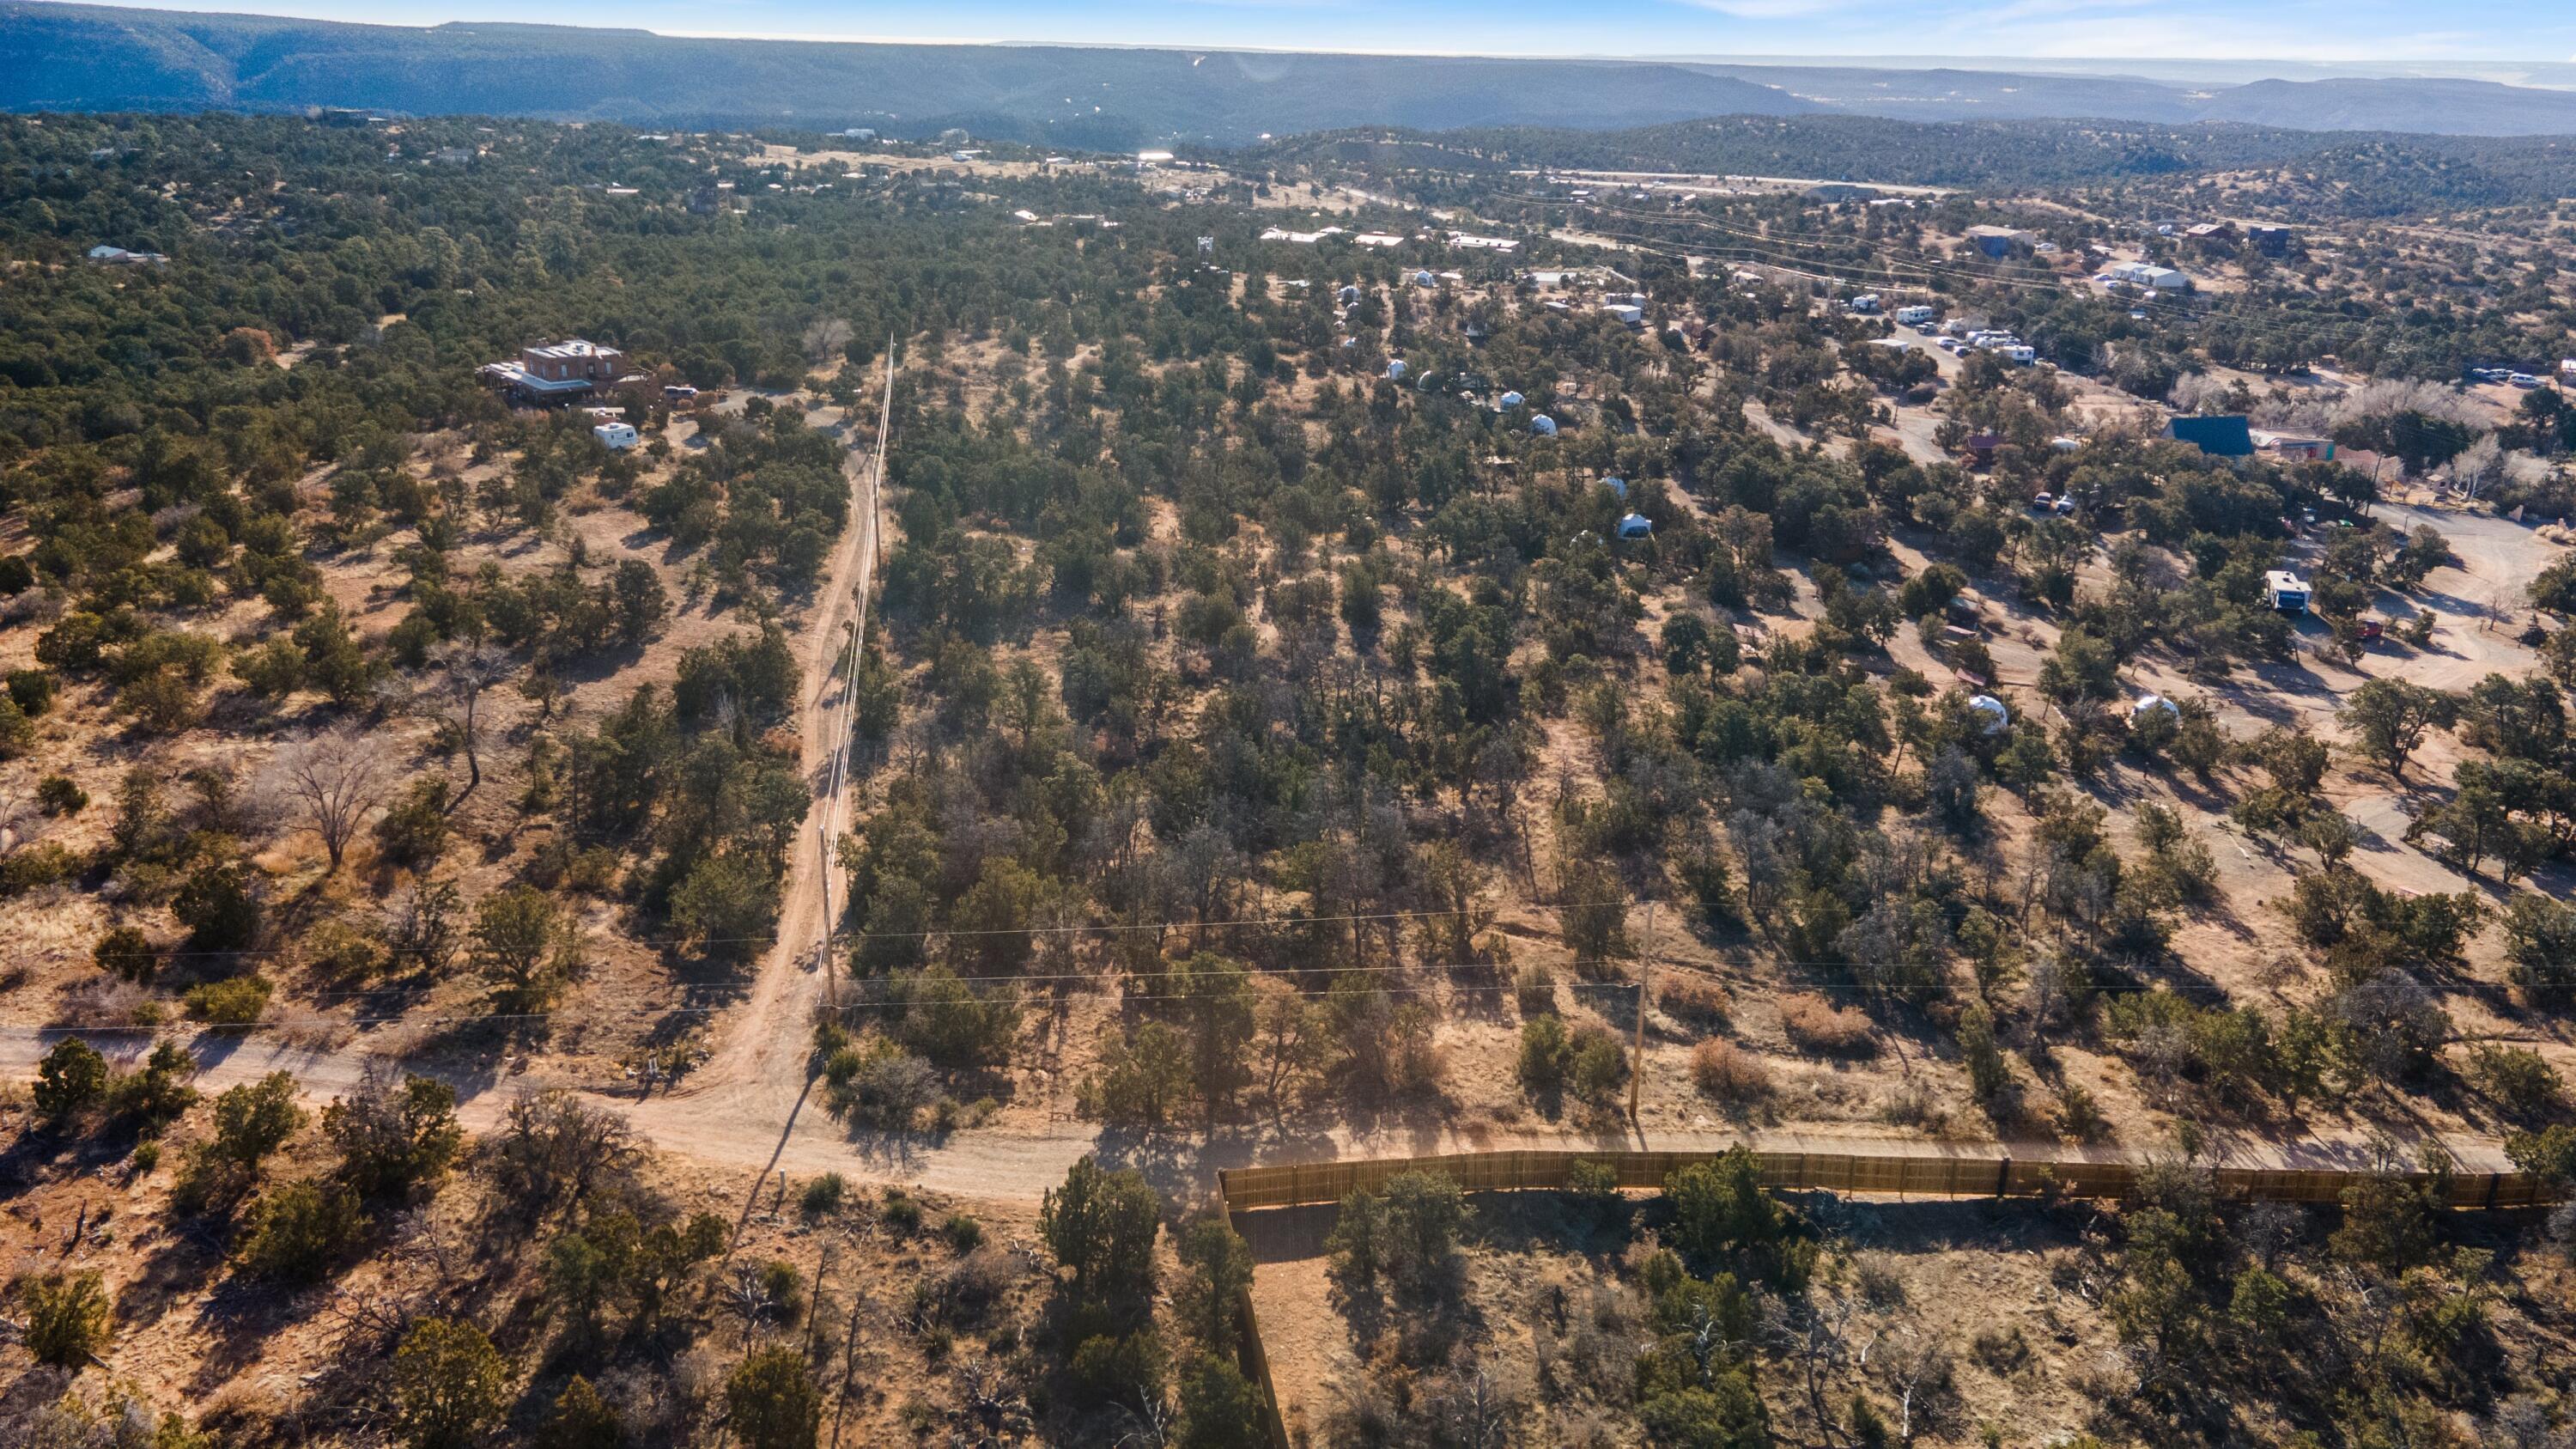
1216,1153,2561,1212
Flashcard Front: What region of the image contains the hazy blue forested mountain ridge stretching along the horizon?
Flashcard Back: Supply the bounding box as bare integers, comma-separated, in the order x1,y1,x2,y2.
0,0,2576,149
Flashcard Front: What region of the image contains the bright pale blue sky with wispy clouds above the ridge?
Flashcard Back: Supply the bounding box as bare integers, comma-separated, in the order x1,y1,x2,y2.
60,0,2576,64
